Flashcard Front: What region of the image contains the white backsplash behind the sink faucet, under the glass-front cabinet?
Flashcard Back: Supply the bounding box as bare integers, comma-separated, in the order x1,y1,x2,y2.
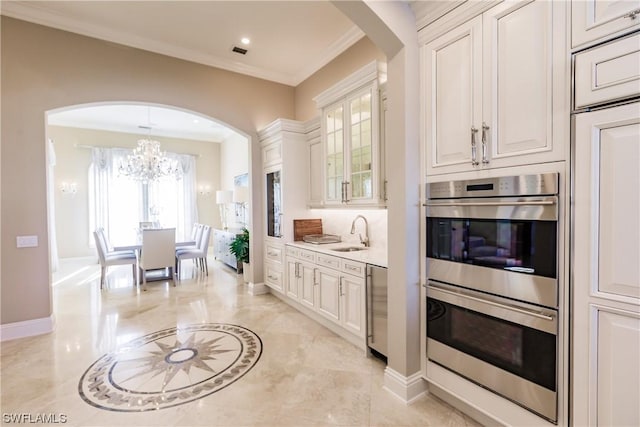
310,209,387,248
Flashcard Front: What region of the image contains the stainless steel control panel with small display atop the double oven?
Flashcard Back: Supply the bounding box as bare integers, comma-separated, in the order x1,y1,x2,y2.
426,172,559,199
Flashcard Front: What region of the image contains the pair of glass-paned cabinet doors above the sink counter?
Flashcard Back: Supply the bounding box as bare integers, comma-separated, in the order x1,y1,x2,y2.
323,86,378,204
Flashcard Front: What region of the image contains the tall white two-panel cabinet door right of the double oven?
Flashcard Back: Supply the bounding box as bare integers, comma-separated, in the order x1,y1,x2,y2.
571,101,640,426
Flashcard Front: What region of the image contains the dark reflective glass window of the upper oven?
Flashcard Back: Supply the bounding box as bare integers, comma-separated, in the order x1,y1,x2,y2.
427,217,557,278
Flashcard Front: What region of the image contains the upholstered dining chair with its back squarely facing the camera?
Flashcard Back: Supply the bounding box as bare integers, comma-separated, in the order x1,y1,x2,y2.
138,228,176,291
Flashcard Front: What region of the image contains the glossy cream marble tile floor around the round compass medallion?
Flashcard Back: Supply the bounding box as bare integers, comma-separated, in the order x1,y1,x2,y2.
0,259,478,427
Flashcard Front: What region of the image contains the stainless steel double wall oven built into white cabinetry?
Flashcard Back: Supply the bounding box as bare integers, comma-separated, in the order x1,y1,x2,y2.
426,173,559,422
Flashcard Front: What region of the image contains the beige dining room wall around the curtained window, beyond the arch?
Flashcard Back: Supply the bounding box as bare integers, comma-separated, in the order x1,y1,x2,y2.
47,126,225,258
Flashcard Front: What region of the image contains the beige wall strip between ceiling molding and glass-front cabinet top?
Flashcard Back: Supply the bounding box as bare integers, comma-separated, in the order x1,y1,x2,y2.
295,37,386,121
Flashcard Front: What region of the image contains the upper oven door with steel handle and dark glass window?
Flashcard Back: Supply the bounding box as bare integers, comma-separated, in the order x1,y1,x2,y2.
426,196,558,307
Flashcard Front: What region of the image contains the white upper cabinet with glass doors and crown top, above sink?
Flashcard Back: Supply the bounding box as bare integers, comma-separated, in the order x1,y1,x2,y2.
314,62,385,207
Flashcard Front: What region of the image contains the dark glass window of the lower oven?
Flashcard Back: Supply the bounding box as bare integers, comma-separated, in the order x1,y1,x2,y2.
427,298,556,391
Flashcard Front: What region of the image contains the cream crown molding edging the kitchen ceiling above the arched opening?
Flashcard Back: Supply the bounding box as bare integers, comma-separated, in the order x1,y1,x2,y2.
0,1,364,87
